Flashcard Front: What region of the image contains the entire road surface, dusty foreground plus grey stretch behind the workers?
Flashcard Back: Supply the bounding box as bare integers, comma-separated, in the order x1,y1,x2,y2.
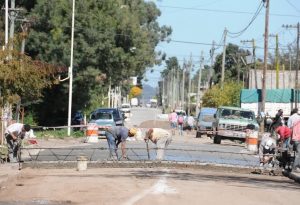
0,108,300,205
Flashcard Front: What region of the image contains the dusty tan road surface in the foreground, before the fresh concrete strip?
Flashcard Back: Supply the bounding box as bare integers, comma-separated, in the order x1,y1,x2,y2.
0,168,300,205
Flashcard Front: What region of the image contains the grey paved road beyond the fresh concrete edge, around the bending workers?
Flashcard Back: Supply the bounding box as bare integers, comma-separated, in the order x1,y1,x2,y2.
21,108,258,167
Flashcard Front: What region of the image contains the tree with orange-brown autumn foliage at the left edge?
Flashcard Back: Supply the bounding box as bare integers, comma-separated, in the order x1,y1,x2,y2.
0,50,60,106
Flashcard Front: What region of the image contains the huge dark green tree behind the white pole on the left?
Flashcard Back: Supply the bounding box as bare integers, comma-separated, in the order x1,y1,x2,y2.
19,0,171,123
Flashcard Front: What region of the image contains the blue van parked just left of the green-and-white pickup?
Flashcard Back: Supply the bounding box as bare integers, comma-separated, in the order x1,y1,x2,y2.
196,107,217,138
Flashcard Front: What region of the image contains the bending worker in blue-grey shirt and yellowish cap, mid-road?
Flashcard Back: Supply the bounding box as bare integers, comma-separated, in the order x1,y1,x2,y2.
105,126,137,160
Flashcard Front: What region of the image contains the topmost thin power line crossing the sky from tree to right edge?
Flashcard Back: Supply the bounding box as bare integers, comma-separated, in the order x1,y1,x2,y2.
159,5,300,18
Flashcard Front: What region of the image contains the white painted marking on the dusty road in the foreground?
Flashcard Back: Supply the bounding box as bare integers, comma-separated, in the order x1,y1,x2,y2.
123,169,177,205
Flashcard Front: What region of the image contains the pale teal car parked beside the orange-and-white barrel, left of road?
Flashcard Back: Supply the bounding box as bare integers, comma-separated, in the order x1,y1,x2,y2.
90,110,116,136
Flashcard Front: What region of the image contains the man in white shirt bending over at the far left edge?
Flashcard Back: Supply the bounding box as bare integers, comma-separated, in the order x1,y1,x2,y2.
4,123,31,162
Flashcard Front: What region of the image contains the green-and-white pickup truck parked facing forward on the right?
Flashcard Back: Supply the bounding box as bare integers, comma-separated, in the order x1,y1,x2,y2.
213,106,259,144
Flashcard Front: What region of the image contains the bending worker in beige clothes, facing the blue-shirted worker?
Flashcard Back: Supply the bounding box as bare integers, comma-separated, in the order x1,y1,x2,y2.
144,128,172,161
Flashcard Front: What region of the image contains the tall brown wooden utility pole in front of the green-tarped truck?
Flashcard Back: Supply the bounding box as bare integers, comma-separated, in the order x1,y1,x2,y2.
260,0,270,131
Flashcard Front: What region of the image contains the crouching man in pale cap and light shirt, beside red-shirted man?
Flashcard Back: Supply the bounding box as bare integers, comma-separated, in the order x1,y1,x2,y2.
258,132,276,165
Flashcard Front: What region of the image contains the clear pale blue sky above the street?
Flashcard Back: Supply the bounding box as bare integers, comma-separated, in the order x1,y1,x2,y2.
146,0,300,87
